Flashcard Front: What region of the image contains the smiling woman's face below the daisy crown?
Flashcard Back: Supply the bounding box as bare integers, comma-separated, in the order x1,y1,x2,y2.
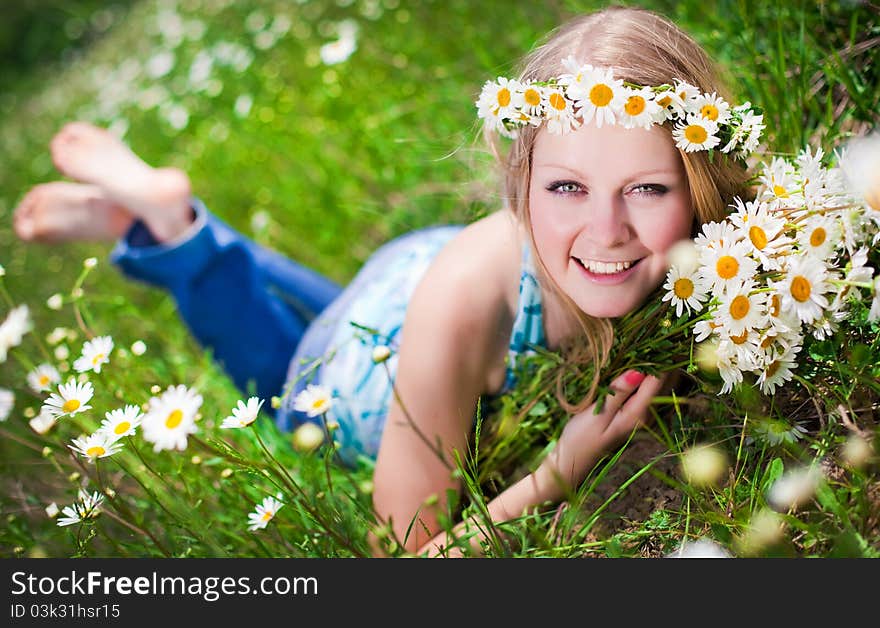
529,124,693,318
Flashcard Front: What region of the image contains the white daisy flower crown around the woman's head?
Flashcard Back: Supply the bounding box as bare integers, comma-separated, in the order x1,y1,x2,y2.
476,57,764,158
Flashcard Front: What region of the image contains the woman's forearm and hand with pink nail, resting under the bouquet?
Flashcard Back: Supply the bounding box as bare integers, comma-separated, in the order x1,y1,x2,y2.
419,371,662,556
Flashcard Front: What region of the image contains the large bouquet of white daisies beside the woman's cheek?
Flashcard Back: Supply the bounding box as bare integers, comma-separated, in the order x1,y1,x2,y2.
663,142,880,394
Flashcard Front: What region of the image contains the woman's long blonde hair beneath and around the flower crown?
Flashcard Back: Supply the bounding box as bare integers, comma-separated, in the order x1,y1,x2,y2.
485,6,747,412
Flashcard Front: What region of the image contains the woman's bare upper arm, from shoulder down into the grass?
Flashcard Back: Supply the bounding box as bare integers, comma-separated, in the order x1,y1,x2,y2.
373,220,517,553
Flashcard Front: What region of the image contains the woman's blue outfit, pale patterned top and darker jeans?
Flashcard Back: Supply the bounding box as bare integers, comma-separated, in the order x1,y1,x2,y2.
111,200,546,464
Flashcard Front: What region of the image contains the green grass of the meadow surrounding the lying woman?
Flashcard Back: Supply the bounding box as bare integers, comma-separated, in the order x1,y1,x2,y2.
0,0,880,556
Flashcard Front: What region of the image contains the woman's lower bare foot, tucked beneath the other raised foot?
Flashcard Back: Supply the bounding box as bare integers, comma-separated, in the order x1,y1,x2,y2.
12,181,134,243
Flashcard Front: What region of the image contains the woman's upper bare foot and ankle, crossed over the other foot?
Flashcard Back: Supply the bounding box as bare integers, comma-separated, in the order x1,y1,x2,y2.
50,122,192,242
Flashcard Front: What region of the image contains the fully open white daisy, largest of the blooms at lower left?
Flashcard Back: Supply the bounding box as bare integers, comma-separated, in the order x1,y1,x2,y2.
141,384,202,452
